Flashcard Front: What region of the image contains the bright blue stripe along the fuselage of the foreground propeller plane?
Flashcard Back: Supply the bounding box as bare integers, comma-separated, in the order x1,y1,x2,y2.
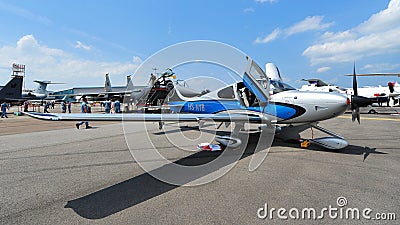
169,100,302,120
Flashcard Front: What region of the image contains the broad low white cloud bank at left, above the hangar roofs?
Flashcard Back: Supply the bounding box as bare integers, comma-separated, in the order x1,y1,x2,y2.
0,35,142,90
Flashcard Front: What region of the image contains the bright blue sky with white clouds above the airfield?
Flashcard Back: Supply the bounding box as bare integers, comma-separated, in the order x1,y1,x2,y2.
0,0,400,90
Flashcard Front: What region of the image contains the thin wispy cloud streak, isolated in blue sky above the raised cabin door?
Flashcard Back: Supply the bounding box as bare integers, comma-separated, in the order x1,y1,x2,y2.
254,16,333,44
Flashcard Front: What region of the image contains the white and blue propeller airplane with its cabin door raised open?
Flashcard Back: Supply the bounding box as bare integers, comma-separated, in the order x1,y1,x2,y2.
27,57,359,149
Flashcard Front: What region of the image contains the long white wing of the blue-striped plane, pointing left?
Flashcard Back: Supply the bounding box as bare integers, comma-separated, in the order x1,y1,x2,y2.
25,112,262,122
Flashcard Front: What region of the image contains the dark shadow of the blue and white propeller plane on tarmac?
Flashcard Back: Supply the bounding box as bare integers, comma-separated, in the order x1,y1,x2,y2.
65,133,387,219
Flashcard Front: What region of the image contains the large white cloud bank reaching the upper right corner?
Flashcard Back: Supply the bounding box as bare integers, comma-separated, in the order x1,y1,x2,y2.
303,0,400,65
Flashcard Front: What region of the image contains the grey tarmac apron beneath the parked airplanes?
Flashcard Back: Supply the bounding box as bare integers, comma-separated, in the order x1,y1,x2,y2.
0,106,400,224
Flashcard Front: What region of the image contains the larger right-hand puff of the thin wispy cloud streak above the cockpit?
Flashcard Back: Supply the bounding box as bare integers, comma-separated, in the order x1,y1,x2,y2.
285,16,333,36
